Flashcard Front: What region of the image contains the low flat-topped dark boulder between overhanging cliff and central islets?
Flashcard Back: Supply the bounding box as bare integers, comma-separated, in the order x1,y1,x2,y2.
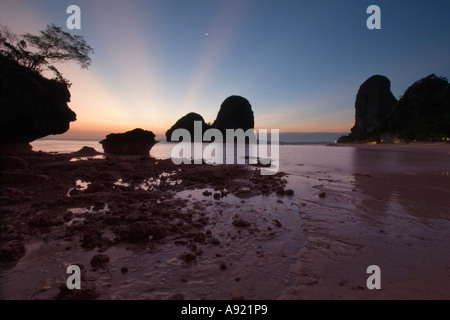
100,129,158,156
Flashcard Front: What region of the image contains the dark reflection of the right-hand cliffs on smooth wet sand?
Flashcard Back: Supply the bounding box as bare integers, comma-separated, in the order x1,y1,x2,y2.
353,149,450,219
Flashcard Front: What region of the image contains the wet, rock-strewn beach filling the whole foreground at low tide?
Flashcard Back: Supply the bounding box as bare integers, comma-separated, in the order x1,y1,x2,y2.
0,144,450,300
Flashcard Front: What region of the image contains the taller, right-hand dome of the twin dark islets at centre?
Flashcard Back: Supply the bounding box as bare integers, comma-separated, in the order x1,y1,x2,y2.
213,96,255,136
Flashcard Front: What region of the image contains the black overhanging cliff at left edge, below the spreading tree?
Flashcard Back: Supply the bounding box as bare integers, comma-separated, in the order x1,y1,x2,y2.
0,56,76,154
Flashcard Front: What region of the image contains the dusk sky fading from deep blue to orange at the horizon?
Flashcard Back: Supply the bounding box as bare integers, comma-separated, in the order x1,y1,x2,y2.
0,0,450,139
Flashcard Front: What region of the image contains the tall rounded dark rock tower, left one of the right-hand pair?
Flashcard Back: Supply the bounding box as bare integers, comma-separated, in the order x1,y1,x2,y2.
351,75,397,134
